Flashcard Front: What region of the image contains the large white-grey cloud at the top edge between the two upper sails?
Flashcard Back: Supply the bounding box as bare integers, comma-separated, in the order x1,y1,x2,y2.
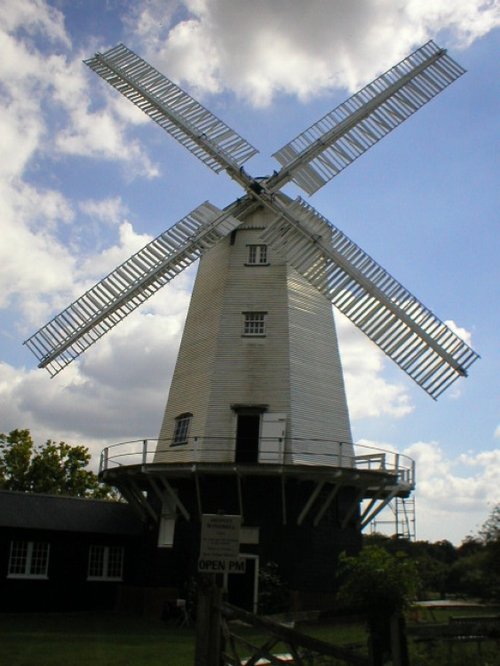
128,0,500,106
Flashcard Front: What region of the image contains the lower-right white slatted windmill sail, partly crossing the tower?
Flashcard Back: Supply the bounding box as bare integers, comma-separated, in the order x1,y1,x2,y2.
262,199,478,398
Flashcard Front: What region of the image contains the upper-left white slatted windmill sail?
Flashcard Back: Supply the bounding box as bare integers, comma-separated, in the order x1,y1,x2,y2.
84,44,258,173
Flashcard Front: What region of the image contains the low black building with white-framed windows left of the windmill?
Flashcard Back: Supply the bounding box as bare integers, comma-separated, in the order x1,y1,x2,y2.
0,491,180,614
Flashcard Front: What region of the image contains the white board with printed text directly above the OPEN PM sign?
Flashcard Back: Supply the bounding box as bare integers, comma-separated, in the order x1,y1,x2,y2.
200,513,241,560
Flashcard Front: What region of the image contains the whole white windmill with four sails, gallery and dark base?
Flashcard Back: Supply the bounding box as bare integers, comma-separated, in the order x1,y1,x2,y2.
26,42,477,604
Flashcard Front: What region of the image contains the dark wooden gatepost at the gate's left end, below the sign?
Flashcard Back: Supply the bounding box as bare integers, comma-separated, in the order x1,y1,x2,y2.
194,574,222,666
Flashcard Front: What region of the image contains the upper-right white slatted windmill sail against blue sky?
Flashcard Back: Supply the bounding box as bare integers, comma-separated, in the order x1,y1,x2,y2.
269,41,465,194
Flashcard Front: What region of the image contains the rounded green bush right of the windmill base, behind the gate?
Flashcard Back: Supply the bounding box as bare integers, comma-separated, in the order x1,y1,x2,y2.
337,546,418,618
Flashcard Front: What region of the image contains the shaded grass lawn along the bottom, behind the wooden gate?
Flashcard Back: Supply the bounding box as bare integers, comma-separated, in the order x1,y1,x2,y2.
0,609,500,666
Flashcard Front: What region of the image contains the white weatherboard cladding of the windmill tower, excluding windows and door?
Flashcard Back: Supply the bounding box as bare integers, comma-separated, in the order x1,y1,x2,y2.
155,204,352,462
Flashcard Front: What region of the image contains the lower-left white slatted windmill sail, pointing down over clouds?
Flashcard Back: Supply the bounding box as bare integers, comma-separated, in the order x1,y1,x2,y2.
24,202,240,376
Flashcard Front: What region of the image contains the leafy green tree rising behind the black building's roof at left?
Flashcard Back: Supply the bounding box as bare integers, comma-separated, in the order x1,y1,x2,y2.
0,429,114,499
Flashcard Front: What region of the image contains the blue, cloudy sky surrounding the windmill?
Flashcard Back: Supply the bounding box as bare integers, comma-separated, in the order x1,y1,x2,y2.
0,0,500,545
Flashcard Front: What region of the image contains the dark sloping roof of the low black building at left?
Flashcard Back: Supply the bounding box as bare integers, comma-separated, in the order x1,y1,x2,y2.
0,490,143,536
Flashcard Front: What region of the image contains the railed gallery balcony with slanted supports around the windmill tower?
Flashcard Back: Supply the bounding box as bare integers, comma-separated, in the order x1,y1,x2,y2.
99,437,415,529
